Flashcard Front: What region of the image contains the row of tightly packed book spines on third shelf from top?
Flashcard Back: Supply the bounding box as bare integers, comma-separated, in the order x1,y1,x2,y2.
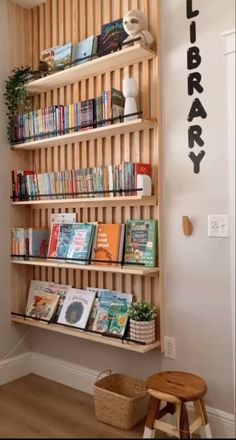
12,162,151,201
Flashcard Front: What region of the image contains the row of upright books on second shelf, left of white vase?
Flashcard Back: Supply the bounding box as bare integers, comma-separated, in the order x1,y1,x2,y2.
13,87,125,143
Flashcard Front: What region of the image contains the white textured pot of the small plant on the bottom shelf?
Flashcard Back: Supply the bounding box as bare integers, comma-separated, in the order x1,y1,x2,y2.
130,319,156,344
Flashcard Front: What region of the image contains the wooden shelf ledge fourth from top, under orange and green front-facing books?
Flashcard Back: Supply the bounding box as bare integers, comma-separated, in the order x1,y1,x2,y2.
11,258,159,276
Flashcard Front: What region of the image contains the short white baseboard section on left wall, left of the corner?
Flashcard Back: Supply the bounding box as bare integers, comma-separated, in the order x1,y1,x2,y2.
0,352,31,385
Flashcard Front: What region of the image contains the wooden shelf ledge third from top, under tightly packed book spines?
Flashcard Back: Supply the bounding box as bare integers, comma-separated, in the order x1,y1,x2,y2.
12,196,157,209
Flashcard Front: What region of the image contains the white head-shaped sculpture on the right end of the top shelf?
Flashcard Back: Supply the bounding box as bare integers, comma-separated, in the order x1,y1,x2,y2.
123,9,153,48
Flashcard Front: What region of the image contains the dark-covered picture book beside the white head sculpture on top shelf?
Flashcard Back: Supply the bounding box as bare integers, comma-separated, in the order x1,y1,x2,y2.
99,18,128,52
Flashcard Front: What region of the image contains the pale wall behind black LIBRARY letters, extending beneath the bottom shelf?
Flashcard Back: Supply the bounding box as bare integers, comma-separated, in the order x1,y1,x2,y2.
28,0,234,413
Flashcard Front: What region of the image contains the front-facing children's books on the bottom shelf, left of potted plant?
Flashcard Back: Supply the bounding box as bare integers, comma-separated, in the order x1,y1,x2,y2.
25,280,133,337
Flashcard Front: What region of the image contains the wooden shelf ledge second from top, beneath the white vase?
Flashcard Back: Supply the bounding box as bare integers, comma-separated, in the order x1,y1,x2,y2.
11,118,157,150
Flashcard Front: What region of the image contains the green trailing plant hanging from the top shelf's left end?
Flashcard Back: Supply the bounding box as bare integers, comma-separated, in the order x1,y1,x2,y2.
4,66,33,145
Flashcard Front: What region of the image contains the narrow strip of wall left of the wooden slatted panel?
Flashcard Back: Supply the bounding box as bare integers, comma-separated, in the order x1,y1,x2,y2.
0,0,27,364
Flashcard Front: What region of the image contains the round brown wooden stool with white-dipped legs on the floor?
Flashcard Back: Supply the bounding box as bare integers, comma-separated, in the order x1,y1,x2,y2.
143,371,212,438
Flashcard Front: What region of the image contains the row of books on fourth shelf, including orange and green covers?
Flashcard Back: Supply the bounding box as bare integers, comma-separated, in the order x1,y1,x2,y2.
12,217,157,267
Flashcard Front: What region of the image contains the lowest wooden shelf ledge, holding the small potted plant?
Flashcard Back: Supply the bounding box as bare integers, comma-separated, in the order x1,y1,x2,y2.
11,314,160,353
